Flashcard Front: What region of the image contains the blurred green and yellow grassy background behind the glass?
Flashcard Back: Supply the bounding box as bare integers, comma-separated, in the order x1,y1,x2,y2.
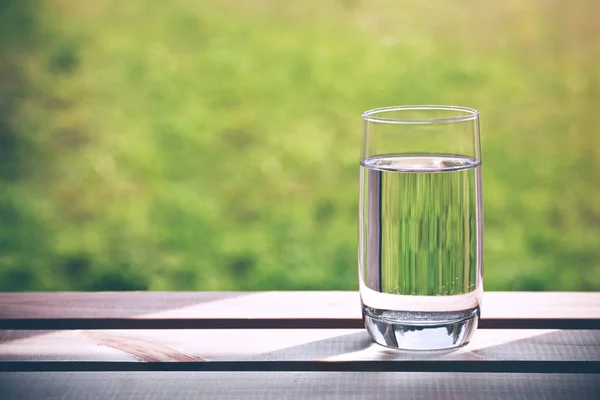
0,0,600,291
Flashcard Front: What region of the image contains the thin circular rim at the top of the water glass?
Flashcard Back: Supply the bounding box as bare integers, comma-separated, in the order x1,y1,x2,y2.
362,105,479,125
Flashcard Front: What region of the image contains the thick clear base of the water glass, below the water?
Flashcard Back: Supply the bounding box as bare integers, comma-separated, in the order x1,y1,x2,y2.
363,305,479,350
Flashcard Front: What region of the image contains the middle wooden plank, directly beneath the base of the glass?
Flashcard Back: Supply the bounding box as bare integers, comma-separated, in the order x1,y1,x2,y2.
0,329,600,368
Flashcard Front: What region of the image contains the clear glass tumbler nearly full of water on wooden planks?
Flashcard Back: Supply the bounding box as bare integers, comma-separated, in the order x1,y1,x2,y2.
358,105,483,350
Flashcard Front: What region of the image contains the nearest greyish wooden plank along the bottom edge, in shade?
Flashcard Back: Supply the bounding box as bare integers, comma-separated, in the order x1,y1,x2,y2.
0,372,600,400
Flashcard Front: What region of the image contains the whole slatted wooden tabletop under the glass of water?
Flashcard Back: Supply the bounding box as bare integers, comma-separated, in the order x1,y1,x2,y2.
0,292,600,400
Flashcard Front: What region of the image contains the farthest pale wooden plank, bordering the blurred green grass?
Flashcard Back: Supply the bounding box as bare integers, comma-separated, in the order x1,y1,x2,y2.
0,291,600,319
